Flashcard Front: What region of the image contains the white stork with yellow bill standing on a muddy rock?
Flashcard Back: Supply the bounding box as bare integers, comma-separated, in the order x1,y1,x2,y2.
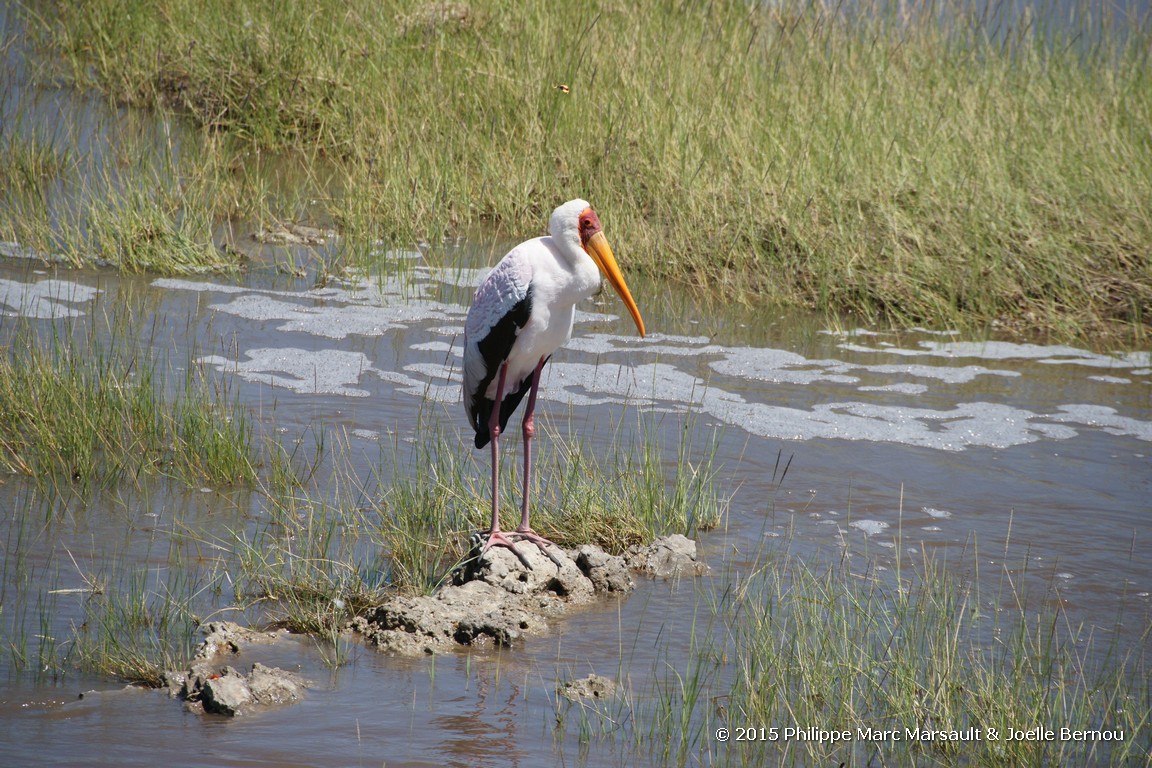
464,200,644,565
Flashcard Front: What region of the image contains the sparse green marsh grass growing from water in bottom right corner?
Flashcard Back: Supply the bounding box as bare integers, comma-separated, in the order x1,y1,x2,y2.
556,529,1152,766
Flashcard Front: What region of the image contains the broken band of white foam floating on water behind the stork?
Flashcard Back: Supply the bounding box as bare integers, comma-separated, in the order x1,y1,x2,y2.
137,276,1152,451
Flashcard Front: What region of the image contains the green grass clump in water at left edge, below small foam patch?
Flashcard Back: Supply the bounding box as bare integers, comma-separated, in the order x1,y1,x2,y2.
0,324,259,491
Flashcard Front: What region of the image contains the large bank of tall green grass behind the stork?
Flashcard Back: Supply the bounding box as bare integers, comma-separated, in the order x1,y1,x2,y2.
18,0,1152,335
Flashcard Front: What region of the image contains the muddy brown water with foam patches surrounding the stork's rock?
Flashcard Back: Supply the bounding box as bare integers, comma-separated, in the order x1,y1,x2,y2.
0,6,1152,767
